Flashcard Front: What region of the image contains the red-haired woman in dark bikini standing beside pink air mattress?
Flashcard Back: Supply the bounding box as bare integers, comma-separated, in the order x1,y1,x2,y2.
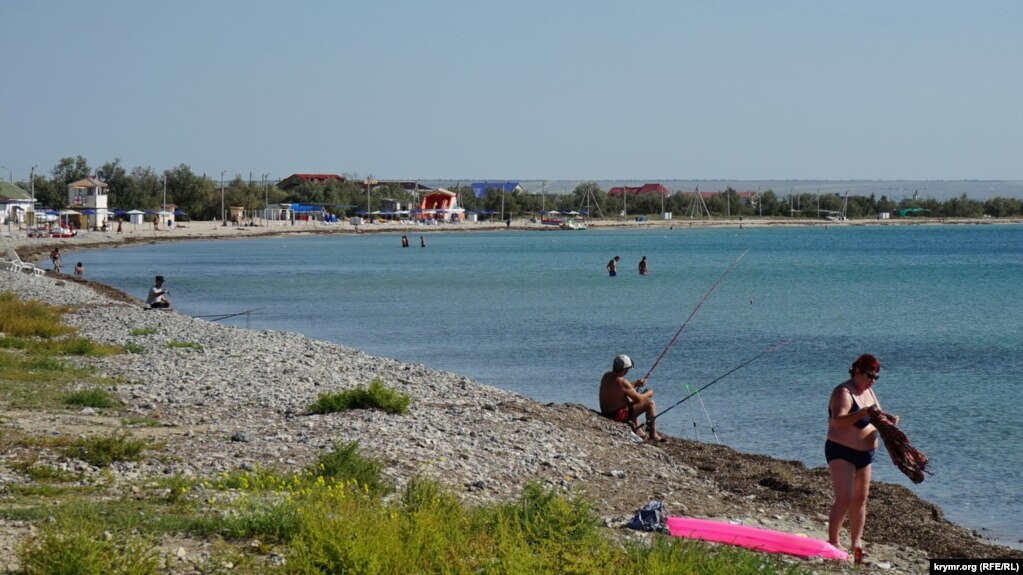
825,354,881,563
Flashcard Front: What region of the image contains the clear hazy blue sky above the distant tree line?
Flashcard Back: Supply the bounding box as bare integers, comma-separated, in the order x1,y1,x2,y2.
0,0,1023,180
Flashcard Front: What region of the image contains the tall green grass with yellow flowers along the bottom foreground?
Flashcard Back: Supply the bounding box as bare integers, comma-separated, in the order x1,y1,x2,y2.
0,452,810,575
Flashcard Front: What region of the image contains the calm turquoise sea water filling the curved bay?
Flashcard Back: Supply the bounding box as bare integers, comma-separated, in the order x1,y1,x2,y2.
76,225,1023,546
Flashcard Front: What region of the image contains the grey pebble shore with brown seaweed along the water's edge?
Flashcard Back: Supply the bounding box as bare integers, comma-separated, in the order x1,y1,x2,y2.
0,233,1023,573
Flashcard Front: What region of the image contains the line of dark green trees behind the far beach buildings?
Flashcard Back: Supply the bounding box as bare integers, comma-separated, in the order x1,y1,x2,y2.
18,156,1023,220
